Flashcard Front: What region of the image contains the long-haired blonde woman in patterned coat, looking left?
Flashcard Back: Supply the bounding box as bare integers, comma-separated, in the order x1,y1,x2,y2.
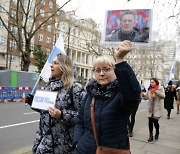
25,54,86,154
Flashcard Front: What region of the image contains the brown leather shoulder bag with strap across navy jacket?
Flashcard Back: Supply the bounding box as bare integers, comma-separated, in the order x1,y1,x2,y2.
91,97,131,154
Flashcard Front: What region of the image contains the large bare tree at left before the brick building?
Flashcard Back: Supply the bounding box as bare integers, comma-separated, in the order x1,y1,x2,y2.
0,0,71,71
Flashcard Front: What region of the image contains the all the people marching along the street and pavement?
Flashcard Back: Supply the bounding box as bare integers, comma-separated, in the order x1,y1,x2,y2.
25,40,180,154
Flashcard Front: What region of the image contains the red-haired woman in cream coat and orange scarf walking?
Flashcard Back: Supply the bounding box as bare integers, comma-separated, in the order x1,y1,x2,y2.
141,78,165,142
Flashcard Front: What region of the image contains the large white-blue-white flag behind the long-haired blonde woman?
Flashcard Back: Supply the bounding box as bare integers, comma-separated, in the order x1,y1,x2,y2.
39,35,66,82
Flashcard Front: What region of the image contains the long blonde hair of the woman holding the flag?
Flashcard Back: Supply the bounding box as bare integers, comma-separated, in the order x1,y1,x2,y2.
57,54,74,89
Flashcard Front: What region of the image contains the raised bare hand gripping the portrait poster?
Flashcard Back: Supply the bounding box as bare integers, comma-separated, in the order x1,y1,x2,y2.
114,40,132,63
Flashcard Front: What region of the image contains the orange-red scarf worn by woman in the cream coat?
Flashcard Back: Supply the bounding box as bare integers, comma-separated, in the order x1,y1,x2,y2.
148,85,159,113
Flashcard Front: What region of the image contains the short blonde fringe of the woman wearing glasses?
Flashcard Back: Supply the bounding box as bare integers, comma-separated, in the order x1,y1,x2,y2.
92,56,115,70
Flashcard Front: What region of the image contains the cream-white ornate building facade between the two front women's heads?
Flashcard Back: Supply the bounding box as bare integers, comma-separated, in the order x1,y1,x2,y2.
56,11,100,84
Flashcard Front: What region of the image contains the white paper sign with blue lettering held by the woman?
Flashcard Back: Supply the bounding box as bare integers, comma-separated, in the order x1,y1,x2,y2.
31,90,57,110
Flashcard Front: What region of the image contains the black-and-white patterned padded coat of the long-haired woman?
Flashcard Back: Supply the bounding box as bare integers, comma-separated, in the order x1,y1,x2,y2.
33,79,85,154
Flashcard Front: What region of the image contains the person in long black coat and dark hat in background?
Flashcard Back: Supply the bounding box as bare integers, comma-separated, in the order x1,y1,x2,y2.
164,80,177,119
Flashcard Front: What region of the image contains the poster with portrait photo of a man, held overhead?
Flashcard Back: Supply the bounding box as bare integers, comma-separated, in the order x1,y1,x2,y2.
101,9,152,45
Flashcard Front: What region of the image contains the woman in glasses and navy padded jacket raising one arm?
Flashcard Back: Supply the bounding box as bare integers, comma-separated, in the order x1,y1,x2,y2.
74,40,141,154
